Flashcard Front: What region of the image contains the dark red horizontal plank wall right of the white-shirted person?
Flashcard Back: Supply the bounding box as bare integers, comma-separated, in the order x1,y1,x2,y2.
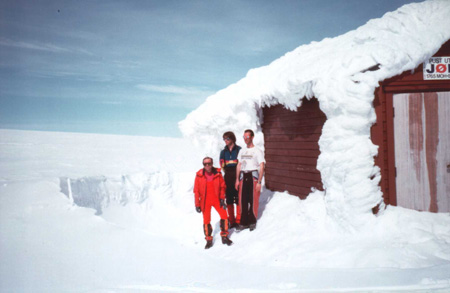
262,98,326,199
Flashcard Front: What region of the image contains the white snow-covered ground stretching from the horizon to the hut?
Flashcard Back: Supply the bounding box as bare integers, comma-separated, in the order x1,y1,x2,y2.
0,130,450,292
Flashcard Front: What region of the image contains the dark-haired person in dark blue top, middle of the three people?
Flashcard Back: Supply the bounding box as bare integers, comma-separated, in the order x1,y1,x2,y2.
220,131,241,228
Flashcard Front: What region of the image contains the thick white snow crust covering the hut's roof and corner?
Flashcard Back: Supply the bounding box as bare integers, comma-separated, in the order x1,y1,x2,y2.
179,0,450,222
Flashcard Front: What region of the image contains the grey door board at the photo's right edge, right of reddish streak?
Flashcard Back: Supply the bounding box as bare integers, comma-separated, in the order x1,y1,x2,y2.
436,92,450,213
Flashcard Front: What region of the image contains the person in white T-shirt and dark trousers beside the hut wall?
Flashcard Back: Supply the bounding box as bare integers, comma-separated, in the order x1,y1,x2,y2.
235,129,266,231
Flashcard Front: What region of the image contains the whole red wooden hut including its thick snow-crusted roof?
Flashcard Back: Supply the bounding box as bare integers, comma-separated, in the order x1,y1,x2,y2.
180,1,450,216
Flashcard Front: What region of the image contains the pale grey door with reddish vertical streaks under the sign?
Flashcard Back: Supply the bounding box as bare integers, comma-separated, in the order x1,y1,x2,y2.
393,92,450,212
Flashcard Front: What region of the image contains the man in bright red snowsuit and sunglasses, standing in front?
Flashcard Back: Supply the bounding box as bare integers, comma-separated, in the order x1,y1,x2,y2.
194,157,233,249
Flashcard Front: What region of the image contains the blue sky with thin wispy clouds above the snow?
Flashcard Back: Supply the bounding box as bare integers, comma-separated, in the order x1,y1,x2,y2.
0,0,420,137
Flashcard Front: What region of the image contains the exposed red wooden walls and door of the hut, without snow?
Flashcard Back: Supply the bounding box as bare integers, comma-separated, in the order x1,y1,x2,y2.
262,41,450,212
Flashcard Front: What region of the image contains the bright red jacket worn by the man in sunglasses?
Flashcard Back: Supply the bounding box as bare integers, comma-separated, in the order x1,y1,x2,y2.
194,168,225,211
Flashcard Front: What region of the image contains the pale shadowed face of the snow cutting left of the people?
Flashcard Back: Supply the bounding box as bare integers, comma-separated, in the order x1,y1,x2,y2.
59,171,173,215
